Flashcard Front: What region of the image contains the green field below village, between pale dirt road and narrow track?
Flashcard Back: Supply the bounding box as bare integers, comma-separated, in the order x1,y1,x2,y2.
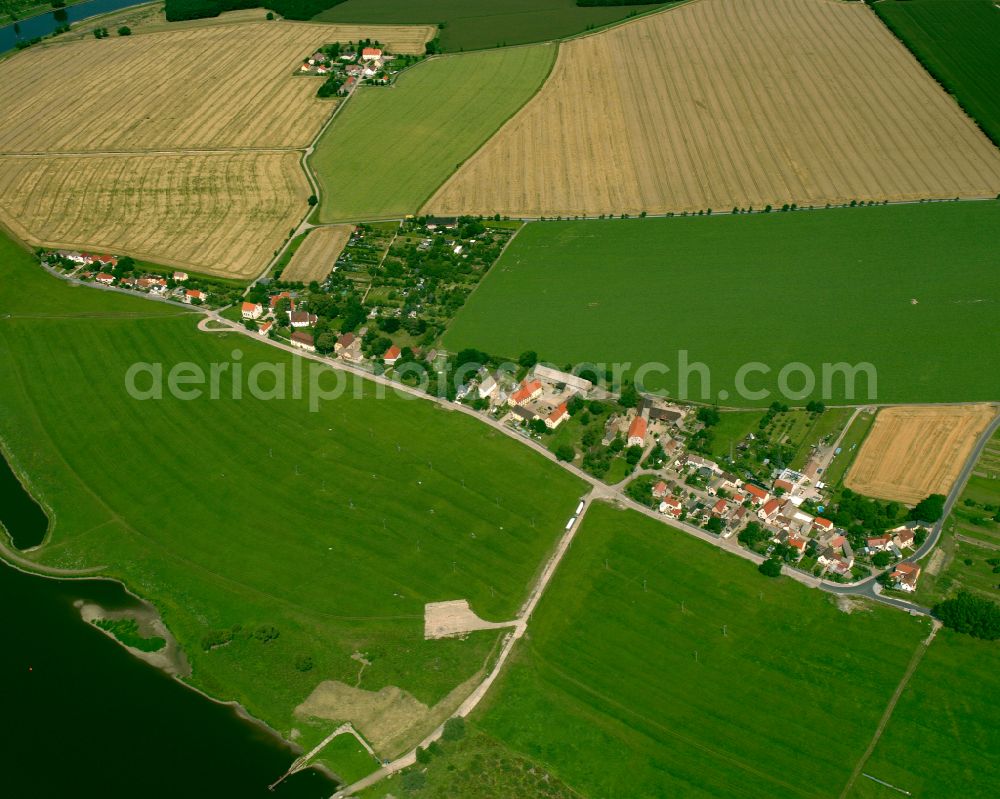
460,504,929,799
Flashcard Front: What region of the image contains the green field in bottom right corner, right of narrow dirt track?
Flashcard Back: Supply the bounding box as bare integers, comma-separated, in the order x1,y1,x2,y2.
849,629,1000,799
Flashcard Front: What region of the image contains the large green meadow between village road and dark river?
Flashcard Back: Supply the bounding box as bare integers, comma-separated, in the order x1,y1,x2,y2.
0,233,582,776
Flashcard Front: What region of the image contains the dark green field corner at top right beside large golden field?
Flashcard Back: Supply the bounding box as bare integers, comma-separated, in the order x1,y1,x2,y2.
872,0,1000,144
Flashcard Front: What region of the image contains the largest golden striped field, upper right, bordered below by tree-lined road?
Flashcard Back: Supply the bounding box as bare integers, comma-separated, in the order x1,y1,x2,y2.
424,0,1000,217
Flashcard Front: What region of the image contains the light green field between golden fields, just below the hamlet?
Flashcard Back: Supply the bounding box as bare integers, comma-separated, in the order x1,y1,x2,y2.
310,45,556,222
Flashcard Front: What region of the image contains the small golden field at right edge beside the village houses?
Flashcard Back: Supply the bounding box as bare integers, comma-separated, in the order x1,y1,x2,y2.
844,404,996,504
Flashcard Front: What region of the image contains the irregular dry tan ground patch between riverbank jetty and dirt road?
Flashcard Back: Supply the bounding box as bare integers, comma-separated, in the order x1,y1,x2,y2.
295,674,482,757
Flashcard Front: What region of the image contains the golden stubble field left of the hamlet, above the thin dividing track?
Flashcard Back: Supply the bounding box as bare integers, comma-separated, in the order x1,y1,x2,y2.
0,22,433,153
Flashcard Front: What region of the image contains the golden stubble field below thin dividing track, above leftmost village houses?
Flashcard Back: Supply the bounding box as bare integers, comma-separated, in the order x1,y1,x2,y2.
0,151,310,278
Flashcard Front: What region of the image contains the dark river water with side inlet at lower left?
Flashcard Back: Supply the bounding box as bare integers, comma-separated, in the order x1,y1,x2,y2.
0,455,336,799
